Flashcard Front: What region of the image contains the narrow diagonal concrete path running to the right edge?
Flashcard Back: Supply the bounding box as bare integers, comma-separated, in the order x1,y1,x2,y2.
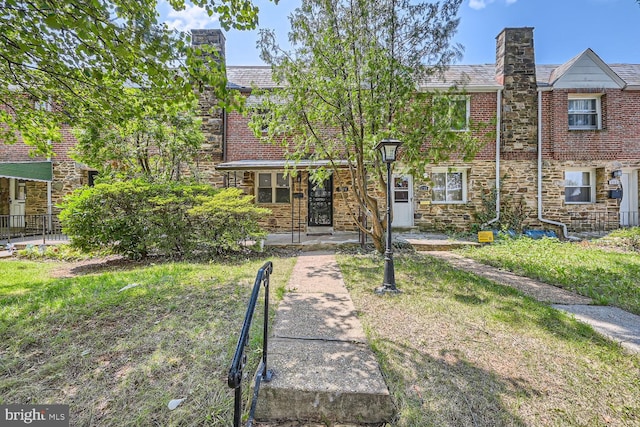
423,251,640,354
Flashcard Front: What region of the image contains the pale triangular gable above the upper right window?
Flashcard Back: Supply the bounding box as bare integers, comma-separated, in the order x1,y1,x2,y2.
549,49,626,89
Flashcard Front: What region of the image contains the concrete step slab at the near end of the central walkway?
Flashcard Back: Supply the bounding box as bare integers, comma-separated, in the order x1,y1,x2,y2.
255,338,394,425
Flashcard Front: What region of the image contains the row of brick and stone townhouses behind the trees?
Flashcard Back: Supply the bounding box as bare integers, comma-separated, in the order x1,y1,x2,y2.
0,28,640,239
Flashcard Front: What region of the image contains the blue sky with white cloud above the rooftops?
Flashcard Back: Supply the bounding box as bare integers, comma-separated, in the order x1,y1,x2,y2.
159,0,640,65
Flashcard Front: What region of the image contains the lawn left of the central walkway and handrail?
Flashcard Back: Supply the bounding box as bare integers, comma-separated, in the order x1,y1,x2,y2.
0,258,295,426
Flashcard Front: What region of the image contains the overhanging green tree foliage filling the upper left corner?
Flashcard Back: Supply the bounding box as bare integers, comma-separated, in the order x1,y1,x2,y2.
0,0,277,153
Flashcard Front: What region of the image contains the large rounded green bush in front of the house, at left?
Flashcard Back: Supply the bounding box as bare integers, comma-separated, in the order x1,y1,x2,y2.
60,180,269,259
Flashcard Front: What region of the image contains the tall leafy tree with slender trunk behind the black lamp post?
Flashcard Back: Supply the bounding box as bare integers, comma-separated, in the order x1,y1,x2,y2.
253,0,490,252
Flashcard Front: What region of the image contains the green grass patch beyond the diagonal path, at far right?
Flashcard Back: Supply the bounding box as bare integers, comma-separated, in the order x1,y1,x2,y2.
461,238,640,314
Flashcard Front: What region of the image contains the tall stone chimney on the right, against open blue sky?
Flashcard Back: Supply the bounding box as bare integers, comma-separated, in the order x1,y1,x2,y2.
496,27,538,153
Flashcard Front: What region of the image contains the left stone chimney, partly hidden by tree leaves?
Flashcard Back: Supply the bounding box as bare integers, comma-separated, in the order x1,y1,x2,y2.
191,29,226,187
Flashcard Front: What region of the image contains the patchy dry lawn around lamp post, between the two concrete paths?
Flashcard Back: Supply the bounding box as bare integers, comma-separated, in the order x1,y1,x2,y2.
338,254,640,427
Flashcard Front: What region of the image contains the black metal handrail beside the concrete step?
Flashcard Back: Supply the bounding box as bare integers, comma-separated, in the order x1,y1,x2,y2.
227,261,273,427
